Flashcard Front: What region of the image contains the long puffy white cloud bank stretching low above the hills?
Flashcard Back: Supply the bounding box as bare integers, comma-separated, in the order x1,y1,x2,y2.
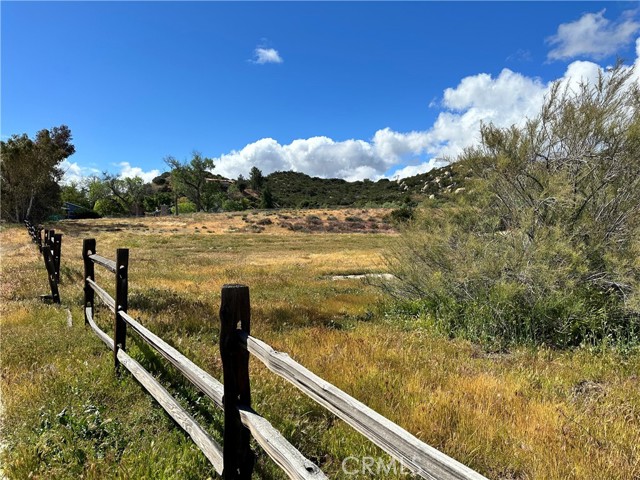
214,47,640,180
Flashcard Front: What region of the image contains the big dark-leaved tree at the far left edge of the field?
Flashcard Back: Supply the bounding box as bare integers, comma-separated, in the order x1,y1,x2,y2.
0,125,75,222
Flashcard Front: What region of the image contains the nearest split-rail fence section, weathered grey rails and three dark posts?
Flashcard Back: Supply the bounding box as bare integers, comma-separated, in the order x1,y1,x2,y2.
77,239,485,480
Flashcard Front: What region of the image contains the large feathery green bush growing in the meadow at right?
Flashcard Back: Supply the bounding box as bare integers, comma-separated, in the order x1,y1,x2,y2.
390,66,640,346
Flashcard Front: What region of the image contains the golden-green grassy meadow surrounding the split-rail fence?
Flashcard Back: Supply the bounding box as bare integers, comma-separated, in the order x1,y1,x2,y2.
0,209,640,479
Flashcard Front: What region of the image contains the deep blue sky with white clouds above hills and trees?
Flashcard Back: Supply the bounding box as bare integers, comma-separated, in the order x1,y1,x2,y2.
0,1,640,180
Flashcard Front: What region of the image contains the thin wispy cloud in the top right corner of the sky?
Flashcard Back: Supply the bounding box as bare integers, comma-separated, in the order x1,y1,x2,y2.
547,10,640,60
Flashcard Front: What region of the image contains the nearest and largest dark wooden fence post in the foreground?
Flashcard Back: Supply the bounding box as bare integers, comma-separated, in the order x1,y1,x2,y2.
220,285,255,480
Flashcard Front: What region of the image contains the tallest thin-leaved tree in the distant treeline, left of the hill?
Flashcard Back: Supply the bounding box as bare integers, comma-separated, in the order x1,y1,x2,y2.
164,152,217,211
